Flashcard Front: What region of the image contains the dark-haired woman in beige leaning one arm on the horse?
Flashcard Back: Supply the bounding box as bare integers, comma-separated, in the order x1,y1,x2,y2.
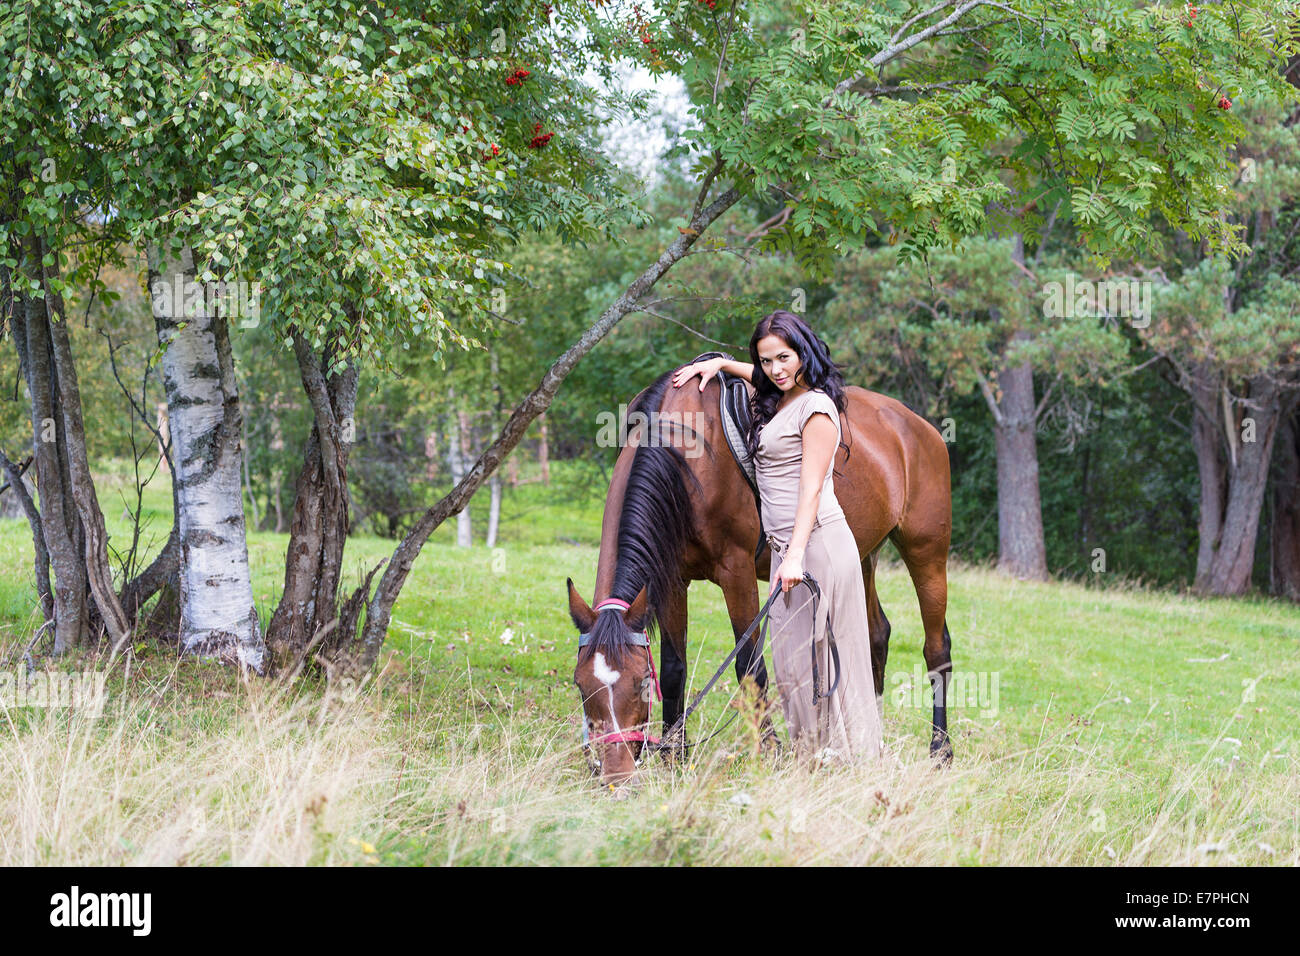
672,310,884,761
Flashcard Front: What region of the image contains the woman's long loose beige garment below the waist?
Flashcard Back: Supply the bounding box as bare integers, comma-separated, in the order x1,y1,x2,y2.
763,516,884,762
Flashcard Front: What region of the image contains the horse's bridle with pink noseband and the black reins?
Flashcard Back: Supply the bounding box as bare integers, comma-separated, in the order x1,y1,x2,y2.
577,580,841,773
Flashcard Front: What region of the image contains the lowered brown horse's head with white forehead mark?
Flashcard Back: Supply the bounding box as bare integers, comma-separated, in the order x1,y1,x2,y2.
568,579,659,786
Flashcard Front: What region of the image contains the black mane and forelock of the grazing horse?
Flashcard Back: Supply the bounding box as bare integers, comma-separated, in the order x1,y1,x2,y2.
579,369,702,667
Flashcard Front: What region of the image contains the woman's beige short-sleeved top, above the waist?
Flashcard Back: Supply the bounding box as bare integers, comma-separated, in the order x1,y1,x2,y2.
754,389,844,541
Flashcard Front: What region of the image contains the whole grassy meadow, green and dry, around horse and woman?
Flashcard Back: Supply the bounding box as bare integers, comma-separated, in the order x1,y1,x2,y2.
0,463,1300,866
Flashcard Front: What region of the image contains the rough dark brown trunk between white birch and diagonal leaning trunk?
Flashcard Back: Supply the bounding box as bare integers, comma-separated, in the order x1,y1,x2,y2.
267,333,359,671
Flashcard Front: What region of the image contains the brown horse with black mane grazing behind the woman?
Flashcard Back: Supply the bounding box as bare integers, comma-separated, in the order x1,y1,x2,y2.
568,361,952,783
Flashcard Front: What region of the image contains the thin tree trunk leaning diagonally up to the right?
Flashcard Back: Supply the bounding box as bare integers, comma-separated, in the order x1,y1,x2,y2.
339,186,740,672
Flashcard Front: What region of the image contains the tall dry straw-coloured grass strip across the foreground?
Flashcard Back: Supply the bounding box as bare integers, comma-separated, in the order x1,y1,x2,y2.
0,642,1300,865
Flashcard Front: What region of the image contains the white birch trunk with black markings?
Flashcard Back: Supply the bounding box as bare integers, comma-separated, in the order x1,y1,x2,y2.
150,240,265,674
